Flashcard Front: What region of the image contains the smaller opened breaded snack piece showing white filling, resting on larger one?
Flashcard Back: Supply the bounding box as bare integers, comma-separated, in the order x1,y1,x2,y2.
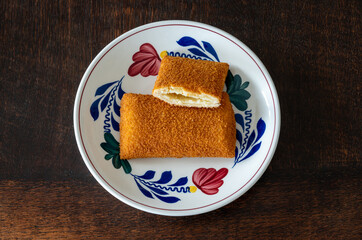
152,56,229,107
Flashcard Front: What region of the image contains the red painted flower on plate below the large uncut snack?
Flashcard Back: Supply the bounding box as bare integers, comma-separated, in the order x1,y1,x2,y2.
192,168,228,195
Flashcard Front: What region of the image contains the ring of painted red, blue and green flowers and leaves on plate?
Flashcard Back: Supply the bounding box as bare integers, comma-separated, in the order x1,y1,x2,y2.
90,36,266,204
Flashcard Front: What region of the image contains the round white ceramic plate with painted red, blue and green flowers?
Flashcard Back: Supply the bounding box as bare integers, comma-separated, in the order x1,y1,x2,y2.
74,21,280,216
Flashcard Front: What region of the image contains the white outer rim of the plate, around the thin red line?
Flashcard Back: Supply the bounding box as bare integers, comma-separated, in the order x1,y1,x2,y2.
73,20,281,216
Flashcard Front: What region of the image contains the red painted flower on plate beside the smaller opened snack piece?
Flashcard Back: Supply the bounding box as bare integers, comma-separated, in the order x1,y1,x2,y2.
128,43,161,77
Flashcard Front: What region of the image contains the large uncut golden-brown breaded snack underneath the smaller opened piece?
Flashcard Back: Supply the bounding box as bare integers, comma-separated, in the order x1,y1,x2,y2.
120,92,236,159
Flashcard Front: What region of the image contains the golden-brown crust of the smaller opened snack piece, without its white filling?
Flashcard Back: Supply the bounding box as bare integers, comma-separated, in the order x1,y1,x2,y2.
153,56,229,101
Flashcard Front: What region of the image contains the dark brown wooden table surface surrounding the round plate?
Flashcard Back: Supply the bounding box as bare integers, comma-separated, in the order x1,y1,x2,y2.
0,0,362,239
